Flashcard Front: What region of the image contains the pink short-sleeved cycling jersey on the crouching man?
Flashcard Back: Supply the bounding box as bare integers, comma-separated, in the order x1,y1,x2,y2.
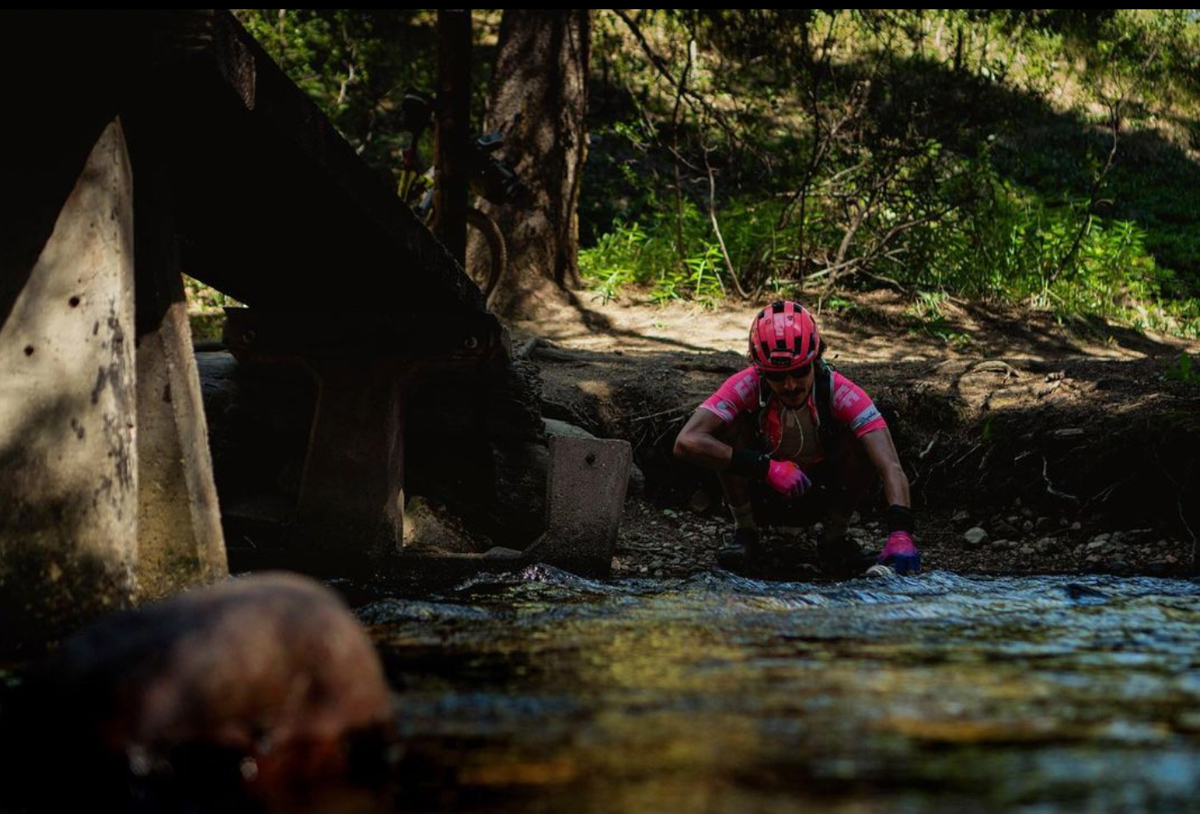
701,366,887,456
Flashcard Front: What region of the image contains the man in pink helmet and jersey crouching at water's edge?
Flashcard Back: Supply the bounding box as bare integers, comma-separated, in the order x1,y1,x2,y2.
674,300,920,579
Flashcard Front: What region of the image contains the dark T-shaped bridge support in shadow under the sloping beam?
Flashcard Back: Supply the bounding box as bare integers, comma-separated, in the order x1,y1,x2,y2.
224,309,432,564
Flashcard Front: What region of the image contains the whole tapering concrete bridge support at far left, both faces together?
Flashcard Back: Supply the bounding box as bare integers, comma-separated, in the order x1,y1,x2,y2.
0,120,226,646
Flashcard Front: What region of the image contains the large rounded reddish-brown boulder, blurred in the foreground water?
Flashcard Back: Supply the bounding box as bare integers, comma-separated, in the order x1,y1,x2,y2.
7,574,394,810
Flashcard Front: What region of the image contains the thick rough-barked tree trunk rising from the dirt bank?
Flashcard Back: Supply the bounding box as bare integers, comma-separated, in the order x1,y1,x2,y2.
472,8,590,319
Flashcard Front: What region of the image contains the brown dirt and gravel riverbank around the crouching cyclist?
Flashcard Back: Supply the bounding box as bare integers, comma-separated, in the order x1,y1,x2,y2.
514,293,1200,576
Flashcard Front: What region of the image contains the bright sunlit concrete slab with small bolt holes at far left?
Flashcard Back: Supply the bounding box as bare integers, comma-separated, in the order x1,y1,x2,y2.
0,120,138,644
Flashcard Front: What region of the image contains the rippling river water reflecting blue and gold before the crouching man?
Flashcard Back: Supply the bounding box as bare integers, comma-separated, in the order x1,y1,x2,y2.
359,567,1200,814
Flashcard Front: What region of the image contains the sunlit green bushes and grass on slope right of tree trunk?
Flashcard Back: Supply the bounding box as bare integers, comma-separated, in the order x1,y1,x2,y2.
581,10,1200,342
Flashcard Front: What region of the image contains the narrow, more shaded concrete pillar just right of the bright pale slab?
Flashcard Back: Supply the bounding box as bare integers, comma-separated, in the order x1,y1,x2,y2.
130,126,229,599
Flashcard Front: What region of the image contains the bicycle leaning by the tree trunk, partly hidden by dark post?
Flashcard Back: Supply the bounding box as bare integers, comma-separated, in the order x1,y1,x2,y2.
396,89,526,305
